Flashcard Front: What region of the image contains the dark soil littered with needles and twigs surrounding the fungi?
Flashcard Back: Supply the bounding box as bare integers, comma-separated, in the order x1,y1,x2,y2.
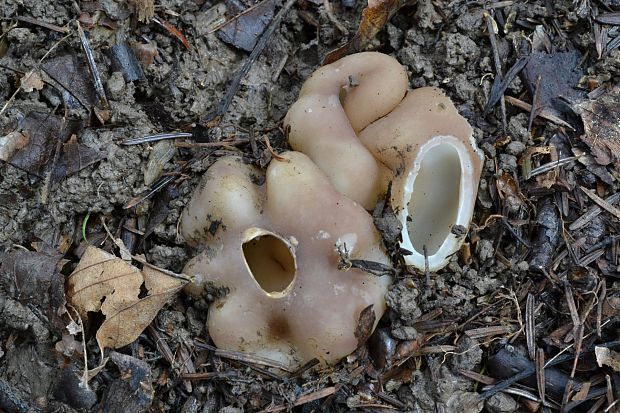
0,0,620,413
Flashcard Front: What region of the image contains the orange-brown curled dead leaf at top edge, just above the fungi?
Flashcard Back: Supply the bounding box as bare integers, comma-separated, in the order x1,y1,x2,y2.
323,0,417,65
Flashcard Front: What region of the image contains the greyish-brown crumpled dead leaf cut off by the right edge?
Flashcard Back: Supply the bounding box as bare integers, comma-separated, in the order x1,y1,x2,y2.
573,88,620,167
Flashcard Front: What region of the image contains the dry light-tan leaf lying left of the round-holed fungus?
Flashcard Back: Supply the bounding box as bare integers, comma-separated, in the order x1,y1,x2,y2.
67,246,184,348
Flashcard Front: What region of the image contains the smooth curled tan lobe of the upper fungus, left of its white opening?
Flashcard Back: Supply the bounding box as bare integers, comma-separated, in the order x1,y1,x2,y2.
284,53,408,209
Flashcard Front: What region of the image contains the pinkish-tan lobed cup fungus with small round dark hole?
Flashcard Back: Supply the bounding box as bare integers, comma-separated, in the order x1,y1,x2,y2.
181,152,391,367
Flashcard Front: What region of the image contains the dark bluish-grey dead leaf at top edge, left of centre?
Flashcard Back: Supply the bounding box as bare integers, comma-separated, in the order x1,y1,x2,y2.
217,0,276,52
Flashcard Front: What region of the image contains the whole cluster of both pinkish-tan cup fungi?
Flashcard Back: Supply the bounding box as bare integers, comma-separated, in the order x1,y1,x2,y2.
181,53,483,368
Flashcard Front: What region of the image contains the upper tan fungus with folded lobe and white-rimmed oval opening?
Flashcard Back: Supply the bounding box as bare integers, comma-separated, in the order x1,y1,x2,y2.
284,52,483,271
